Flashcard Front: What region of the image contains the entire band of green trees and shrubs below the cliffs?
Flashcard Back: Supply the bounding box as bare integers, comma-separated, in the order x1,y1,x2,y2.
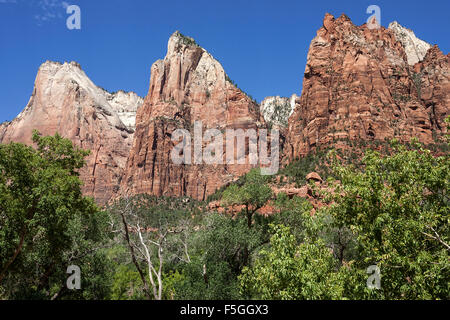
0,129,450,300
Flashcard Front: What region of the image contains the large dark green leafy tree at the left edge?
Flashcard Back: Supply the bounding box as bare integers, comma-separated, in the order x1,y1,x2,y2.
0,132,111,298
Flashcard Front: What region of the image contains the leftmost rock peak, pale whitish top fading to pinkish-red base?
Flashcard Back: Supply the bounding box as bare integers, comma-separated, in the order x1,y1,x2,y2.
0,61,142,204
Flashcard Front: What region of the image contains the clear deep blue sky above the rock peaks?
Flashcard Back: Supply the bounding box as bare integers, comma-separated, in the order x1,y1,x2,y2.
0,0,450,122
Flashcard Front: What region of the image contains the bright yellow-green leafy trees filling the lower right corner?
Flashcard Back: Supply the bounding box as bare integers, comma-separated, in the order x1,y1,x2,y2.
240,139,450,299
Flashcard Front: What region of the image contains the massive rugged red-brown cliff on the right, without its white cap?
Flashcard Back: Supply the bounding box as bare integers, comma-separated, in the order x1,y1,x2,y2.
285,14,449,160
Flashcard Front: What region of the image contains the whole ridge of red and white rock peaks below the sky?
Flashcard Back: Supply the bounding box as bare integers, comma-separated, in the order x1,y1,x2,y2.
0,14,450,204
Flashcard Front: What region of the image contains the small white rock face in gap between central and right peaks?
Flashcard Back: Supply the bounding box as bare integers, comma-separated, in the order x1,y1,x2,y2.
260,94,297,127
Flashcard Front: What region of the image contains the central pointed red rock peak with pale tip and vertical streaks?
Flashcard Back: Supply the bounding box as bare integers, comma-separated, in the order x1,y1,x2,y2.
121,32,264,200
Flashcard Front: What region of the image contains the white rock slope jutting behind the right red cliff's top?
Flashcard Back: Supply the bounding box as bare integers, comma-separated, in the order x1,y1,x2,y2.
389,21,431,66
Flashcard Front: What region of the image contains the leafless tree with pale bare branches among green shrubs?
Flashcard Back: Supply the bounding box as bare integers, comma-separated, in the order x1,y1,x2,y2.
108,194,198,300
